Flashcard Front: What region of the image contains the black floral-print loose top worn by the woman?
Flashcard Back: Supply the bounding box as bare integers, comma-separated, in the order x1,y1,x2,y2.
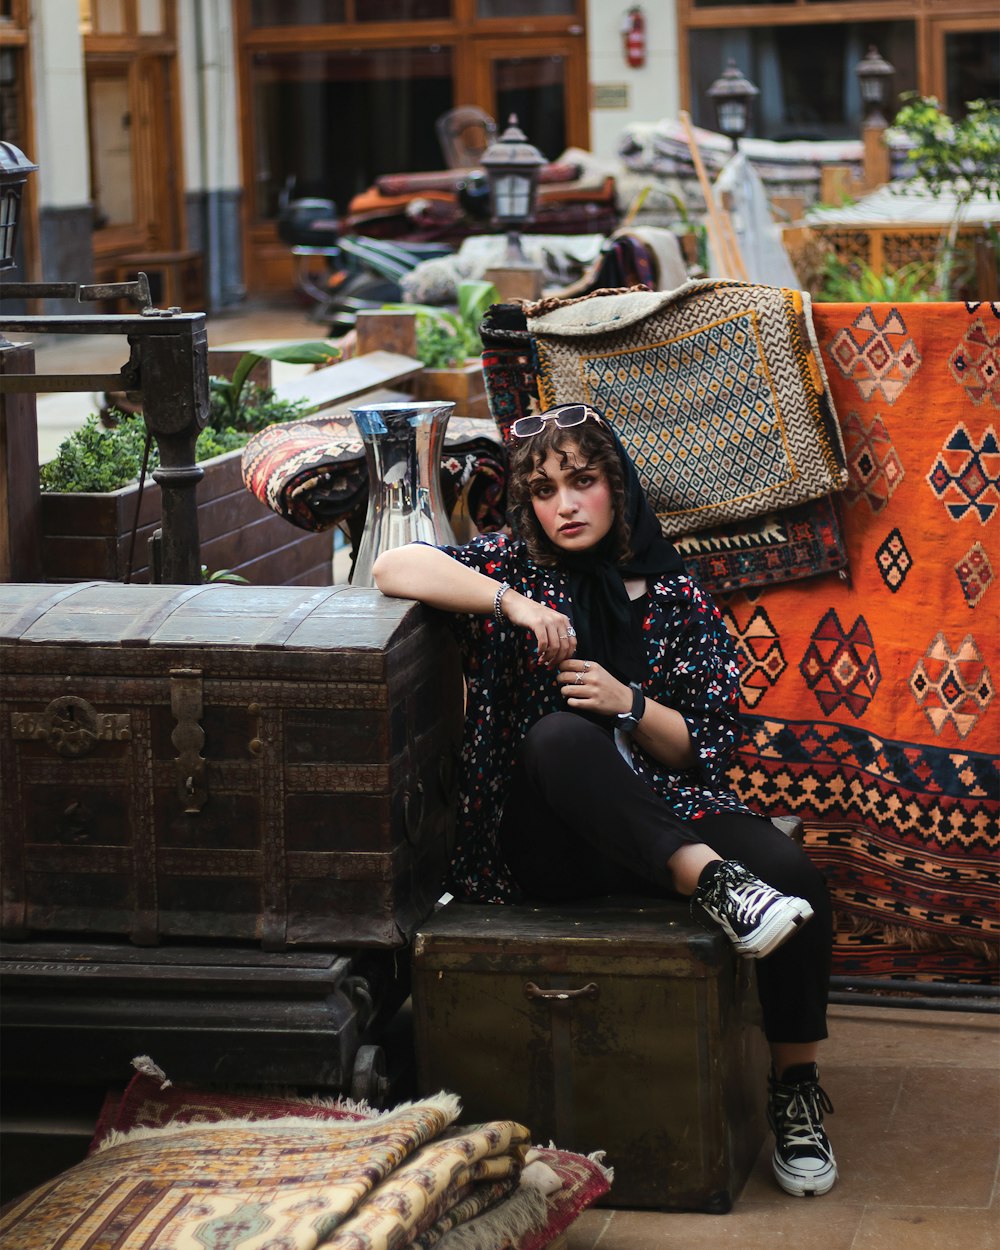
441,534,749,903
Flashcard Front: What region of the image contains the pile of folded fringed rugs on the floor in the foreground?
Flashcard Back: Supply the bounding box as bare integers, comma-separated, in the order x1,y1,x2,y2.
0,1056,611,1250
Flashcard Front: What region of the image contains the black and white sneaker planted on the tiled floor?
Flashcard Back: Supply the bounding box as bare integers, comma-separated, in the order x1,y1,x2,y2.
768,1064,836,1198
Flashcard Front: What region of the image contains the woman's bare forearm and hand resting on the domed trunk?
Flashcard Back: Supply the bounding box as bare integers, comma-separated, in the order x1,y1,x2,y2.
373,543,576,665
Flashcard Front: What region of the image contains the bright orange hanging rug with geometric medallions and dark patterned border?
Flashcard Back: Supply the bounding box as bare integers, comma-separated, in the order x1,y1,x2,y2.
720,304,1000,979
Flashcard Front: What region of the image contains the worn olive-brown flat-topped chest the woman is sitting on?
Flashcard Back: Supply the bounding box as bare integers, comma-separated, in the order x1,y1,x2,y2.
413,900,769,1211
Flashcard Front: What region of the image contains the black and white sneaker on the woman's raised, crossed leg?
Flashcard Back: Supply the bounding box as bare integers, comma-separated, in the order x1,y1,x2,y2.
691,860,813,959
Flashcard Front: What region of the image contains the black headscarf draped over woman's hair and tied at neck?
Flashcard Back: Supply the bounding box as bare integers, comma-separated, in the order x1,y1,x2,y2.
558,423,684,683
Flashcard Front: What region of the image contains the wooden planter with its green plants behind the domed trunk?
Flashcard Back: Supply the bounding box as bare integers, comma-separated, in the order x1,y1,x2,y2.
40,343,339,585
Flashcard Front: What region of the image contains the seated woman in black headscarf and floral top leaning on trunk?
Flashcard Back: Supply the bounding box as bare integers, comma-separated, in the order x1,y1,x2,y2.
375,404,836,1195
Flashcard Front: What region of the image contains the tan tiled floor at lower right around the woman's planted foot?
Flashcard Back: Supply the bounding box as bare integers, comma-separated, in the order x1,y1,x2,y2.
568,1006,1000,1250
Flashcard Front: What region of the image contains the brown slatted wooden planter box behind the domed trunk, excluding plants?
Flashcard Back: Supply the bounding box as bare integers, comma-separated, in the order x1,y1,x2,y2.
41,450,334,586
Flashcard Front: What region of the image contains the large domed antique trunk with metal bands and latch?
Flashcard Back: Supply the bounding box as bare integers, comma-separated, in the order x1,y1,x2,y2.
0,583,461,950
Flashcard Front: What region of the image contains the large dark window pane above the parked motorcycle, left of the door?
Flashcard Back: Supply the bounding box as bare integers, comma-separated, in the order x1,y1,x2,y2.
253,48,453,219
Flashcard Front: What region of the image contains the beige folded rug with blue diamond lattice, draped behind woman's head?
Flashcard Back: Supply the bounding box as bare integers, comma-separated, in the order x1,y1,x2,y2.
525,281,846,536
